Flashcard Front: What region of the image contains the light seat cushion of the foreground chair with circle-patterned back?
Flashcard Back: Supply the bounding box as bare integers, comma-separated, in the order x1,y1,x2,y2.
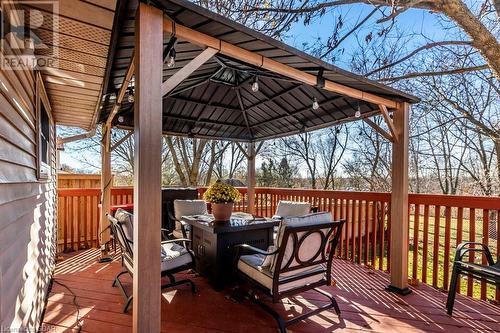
238,254,325,294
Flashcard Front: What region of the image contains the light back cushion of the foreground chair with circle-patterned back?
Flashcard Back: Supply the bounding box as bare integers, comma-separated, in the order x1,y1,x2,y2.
270,212,332,272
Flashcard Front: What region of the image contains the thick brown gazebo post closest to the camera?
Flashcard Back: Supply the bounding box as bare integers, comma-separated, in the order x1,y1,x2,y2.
132,2,163,333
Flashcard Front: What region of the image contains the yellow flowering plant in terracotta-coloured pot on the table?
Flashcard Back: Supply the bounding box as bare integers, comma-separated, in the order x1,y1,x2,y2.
203,181,241,221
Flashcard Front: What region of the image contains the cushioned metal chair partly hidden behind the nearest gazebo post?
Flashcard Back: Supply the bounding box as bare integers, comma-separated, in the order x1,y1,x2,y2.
108,210,196,312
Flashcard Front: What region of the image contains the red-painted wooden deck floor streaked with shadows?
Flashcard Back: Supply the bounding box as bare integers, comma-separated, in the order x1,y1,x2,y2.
42,249,500,333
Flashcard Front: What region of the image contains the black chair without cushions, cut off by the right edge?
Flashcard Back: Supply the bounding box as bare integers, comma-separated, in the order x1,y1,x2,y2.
446,242,500,316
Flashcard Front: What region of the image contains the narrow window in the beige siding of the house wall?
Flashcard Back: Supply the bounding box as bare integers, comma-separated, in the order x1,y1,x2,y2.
36,75,51,179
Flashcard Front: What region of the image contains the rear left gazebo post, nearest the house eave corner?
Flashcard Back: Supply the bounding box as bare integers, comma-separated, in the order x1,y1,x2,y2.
99,125,113,262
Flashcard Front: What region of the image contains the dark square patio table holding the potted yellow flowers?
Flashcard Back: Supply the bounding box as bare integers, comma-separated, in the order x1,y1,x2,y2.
182,213,279,290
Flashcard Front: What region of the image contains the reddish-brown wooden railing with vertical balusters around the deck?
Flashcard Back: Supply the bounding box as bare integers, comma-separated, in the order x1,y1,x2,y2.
58,188,500,301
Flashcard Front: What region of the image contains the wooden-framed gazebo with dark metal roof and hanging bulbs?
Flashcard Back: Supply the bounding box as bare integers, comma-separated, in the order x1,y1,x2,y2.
50,0,418,332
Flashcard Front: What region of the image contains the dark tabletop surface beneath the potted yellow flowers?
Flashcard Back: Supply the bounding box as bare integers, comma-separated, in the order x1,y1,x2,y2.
182,213,280,234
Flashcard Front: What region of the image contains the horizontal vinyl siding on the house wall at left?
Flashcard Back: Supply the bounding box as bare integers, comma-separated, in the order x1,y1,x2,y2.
0,65,57,330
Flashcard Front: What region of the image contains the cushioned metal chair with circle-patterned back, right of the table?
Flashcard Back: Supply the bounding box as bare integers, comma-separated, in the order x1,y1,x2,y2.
236,213,345,332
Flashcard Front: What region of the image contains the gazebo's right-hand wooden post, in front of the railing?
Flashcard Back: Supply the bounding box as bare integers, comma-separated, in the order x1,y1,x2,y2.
387,103,411,295
